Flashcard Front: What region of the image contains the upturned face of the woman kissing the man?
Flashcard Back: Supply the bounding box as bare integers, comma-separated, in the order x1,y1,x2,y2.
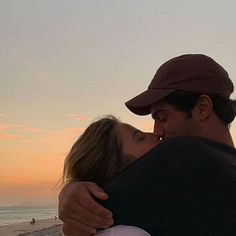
116,123,159,159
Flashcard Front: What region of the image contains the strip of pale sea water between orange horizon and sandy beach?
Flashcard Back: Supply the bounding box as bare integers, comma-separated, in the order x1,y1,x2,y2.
0,206,57,226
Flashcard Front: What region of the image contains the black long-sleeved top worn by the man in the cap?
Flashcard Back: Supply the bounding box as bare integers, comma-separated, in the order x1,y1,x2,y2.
101,137,236,236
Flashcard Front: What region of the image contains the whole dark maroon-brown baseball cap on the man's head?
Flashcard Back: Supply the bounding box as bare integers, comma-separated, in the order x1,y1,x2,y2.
125,54,234,115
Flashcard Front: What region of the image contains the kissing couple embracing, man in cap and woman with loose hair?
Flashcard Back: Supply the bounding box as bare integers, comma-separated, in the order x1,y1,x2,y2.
59,54,236,236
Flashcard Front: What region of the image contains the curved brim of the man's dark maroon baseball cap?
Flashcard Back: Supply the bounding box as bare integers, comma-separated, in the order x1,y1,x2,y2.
125,89,176,116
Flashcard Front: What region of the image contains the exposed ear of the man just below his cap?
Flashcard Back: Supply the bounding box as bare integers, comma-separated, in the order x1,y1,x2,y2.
192,95,213,120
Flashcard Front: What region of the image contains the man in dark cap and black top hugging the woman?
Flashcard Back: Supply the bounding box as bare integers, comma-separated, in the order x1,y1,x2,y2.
59,54,236,236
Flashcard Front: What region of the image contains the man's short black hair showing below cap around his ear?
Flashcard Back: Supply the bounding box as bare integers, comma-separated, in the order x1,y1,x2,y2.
162,90,236,126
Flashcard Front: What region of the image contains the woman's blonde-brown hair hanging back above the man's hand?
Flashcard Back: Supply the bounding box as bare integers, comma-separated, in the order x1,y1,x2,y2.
62,116,130,185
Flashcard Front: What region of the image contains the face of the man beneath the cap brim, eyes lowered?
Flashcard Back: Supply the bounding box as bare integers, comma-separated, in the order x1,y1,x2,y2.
151,102,200,140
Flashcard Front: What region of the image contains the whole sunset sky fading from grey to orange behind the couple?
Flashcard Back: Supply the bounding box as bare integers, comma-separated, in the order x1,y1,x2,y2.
0,0,236,206
